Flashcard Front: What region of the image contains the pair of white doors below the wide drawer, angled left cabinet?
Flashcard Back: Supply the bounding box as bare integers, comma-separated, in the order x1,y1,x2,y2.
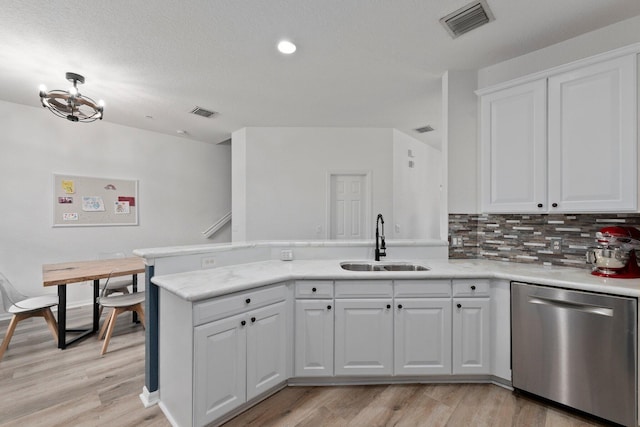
194,301,287,425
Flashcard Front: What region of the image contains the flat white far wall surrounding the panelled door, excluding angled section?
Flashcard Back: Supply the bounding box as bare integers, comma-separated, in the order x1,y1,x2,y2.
232,127,393,241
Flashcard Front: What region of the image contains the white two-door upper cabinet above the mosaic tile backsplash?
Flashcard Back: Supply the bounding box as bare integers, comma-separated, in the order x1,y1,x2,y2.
480,54,638,213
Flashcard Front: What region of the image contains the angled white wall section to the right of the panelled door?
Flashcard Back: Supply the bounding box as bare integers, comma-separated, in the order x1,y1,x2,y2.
387,130,446,239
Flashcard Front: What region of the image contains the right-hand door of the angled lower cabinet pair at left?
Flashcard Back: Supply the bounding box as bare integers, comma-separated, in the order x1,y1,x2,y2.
247,301,287,400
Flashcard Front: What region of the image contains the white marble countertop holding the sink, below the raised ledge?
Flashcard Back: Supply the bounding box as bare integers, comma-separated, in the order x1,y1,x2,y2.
151,260,640,301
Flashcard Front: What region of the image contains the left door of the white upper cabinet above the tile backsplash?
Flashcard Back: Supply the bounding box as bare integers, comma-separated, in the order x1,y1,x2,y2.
480,80,547,212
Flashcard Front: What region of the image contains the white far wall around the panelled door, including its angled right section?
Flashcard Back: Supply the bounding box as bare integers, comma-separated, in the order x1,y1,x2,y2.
232,127,440,242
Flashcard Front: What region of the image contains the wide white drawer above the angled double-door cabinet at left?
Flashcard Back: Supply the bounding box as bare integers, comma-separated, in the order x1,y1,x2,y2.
193,285,287,326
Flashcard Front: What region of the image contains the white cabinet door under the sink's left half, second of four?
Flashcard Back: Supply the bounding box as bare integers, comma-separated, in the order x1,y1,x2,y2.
334,298,393,375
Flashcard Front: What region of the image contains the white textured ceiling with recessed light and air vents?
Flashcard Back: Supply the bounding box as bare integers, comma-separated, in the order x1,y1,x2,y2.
0,0,640,145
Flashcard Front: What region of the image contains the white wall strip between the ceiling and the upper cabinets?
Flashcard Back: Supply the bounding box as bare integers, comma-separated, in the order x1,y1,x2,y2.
478,16,640,88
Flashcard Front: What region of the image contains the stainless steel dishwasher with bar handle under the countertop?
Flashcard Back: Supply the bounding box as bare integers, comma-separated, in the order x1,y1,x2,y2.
511,282,638,426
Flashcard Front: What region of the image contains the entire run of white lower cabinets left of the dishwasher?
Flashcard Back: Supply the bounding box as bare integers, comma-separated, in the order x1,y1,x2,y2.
176,279,504,426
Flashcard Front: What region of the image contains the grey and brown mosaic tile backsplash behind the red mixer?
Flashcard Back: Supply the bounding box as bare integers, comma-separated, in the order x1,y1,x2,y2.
449,213,640,268
